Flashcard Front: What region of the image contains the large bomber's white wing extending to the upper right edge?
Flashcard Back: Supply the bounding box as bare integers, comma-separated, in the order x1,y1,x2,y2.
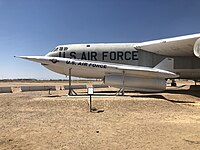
134,33,200,56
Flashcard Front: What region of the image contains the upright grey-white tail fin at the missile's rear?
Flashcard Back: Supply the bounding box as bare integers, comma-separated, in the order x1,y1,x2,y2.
154,57,174,72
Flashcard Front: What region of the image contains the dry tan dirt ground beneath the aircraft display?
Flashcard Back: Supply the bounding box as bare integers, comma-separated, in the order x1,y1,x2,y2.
0,81,200,150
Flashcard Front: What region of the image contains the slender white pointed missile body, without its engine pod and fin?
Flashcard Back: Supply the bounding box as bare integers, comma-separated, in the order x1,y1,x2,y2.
16,56,178,79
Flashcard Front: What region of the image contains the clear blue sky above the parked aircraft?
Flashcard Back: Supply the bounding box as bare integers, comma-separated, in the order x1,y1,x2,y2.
0,0,200,79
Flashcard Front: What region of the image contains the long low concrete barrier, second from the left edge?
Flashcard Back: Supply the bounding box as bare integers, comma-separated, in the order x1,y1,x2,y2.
21,86,56,92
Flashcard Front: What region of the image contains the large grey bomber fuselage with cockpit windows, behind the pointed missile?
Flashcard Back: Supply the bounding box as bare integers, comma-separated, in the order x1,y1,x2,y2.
46,43,200,79
